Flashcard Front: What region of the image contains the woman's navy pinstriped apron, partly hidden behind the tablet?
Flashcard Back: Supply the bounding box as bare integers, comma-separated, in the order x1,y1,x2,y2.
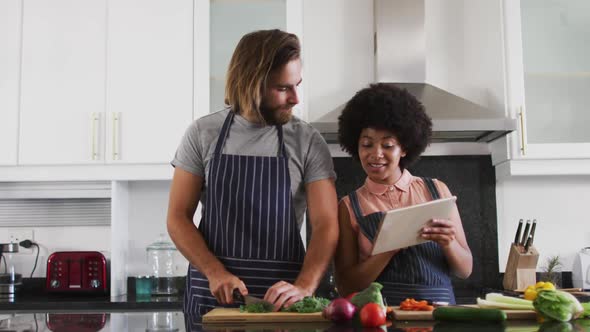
348,178,455,305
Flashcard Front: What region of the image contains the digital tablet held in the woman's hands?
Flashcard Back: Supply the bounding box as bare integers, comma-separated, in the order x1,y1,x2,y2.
371,196,457,255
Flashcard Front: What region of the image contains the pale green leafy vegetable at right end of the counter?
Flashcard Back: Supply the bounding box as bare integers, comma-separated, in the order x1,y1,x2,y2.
533,290,584,322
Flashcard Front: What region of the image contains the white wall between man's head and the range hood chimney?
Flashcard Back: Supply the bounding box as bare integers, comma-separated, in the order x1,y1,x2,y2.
302,0,374,121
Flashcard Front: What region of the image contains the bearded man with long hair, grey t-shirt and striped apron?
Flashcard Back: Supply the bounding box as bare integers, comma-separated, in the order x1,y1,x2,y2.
167,30,338,321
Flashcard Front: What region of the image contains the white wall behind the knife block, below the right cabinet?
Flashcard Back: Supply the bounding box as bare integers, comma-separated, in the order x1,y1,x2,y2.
496,176,590,272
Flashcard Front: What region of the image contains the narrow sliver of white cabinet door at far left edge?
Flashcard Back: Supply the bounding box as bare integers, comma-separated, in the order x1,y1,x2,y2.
0,0,22,165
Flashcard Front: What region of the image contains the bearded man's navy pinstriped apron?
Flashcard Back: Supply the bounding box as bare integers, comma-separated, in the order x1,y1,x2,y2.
184,111,305,329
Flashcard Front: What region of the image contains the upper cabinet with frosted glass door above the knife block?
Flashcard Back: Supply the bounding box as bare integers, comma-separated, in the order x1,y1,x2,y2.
504,0,590,162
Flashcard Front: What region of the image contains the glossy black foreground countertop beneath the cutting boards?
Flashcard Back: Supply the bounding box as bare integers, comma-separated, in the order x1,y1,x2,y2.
0,311,590,332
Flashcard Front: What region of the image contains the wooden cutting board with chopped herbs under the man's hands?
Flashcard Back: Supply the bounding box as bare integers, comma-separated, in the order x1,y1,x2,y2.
203,308,327,323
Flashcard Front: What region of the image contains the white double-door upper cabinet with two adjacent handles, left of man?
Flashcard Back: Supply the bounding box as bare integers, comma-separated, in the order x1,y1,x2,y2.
19,0,193,165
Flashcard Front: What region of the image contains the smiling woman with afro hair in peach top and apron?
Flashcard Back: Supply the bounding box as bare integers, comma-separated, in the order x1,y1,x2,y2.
335,83,473,305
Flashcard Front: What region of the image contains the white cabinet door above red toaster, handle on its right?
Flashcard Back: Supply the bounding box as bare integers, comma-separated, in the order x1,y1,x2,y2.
19,0,107,165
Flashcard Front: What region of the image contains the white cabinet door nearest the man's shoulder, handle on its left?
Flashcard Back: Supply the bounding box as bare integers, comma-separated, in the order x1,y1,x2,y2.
105,0,193,163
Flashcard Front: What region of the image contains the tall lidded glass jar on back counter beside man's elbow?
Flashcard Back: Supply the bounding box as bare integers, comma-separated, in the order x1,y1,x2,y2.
146,234,178,295
